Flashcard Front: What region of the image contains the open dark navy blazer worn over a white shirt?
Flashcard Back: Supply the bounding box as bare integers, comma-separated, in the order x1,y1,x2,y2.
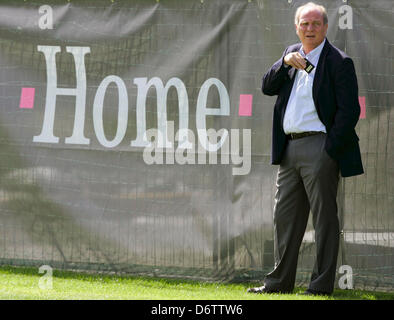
262,39,364,177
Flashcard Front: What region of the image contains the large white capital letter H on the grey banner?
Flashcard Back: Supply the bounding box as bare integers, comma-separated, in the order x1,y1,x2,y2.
33,46,90,144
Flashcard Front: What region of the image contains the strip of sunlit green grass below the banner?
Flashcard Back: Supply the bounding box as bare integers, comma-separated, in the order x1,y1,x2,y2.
0,266,394,300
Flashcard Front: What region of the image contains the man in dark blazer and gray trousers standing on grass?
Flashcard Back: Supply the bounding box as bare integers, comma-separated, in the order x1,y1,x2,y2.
248,2,363,295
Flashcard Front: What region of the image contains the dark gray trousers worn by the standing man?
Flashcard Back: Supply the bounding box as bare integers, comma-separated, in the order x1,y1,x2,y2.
264,133,340,293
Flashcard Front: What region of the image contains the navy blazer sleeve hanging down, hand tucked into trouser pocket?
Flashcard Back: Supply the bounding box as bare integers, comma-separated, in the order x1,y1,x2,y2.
326,57,360,158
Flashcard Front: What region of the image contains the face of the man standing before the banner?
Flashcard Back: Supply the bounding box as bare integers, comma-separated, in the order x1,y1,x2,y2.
296,8,328,50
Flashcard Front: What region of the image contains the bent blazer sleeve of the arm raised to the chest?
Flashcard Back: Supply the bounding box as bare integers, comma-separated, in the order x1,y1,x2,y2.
261,48,291,96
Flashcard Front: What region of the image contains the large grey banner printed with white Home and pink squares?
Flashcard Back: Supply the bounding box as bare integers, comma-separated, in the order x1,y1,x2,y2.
0,0,394,289
